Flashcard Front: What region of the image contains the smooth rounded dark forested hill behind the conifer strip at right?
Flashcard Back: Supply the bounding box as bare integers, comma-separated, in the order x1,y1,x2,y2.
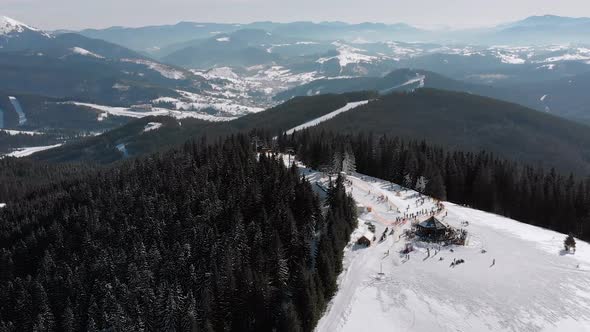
312,89,590,176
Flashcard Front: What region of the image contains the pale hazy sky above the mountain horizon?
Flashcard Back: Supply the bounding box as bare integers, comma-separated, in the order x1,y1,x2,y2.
0,0,590,29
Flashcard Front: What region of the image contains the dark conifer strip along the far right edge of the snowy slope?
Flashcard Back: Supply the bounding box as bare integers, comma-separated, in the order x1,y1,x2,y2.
279,129,590,240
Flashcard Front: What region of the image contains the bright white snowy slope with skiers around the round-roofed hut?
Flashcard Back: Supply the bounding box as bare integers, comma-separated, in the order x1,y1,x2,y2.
280,156,590,332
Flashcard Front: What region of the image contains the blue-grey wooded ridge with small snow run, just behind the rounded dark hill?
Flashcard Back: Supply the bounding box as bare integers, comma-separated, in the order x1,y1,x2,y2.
275,69,590,123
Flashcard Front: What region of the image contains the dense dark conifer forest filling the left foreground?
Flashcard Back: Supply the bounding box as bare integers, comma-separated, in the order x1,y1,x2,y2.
0,136,356,331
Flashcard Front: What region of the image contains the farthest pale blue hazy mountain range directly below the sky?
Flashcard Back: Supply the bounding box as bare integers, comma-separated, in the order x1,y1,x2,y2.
80,15,590,52
